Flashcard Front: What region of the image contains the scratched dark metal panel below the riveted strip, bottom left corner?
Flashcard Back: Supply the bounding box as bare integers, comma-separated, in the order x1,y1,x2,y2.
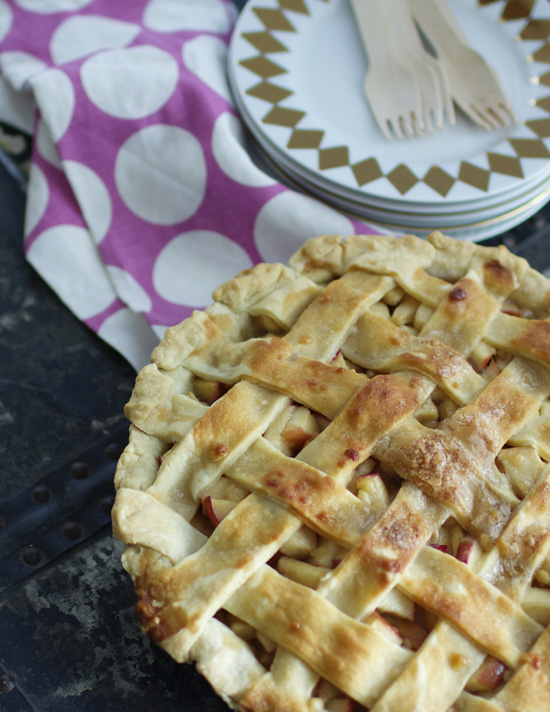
0,527,227,712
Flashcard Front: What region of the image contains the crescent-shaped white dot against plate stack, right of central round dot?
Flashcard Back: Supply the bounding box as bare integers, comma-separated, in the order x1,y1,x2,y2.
212,112,276,186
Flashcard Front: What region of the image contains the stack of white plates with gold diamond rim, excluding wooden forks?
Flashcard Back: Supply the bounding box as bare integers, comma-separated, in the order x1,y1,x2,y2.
229,0,550,240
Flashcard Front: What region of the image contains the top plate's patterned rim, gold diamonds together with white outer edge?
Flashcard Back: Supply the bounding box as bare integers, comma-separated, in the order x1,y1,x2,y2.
235,0,550,202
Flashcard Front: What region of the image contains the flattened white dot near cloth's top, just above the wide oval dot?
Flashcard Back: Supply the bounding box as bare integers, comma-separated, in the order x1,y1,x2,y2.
50,15,140,64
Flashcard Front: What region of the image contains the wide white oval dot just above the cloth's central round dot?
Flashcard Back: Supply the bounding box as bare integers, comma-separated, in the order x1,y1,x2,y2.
80,45,179,119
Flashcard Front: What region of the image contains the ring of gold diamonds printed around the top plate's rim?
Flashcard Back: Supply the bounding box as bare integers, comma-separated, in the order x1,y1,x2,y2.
240,0,550,197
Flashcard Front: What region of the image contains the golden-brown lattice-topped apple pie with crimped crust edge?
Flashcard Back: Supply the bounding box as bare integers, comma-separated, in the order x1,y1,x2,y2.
113,233,550,712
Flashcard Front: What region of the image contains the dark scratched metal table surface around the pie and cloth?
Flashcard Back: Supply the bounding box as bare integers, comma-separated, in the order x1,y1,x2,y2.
0,115,550,712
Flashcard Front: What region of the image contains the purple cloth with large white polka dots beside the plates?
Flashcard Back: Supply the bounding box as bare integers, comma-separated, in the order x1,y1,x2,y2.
0,0,378,369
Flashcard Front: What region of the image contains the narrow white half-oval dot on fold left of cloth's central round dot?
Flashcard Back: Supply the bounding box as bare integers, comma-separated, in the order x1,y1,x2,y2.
63,161,113,244
